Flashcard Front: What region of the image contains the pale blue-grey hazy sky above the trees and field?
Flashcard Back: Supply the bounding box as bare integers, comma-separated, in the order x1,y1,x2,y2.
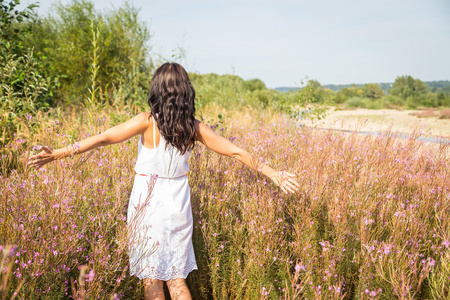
29,0,450,88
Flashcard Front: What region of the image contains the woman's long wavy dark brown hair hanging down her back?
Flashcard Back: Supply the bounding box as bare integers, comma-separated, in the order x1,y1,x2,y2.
148,63,195,155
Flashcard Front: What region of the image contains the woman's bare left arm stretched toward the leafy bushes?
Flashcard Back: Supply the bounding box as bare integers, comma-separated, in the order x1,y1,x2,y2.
28,113,150,169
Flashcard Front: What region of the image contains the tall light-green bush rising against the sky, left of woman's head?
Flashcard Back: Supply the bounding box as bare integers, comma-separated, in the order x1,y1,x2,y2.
23,0,153,104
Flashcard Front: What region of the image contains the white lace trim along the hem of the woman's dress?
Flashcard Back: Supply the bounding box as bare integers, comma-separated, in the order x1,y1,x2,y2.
130,260,197,281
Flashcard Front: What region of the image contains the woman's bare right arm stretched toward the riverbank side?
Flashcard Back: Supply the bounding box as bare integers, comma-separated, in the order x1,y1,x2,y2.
196,120,299,193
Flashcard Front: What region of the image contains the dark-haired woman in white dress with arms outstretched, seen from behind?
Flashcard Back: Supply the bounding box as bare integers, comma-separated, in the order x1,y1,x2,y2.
29,63,298,299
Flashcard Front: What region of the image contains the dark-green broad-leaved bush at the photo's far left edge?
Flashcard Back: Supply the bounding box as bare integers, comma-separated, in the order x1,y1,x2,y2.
0,0,58,145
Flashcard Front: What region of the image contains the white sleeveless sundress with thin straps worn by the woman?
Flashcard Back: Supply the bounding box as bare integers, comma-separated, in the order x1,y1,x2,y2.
127,119,197,281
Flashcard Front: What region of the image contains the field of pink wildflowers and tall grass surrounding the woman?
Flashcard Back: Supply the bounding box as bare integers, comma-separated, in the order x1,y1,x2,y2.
0,106,450,299
